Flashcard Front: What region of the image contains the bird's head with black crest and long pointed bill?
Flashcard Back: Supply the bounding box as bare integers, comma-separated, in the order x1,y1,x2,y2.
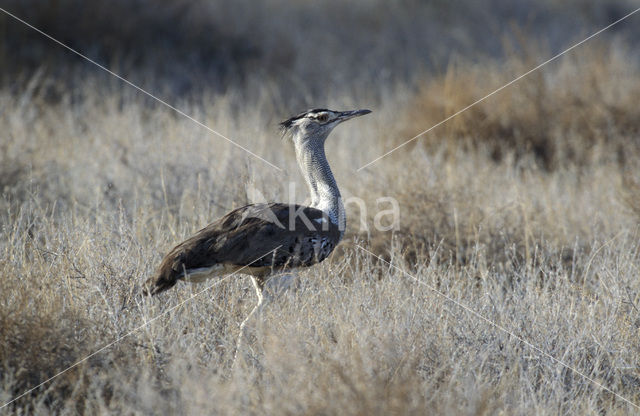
280,108,371,145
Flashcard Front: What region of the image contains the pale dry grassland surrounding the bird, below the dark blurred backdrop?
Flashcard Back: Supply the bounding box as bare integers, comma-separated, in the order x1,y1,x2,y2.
0,1,640,415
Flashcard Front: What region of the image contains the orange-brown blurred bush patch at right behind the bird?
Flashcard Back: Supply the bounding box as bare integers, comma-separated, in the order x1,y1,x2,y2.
397,40,640,170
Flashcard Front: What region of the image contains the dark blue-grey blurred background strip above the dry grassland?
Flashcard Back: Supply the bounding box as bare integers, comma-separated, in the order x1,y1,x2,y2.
0,0,640,105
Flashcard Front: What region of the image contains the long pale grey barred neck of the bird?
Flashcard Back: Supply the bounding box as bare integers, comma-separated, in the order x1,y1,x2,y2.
296,142,346,232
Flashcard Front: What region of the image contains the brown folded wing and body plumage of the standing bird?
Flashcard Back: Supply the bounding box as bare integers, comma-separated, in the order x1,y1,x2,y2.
148,203,341,295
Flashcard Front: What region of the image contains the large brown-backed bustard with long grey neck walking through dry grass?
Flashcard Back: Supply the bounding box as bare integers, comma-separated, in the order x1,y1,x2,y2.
144,108,371,360
